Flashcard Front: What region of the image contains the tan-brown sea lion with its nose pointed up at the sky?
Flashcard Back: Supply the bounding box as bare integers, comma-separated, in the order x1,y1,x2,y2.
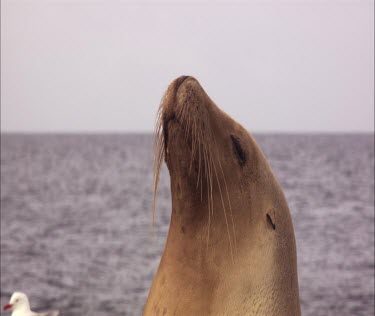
143,76,301,316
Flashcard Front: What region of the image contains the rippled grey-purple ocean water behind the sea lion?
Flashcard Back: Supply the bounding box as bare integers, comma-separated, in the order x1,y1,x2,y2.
0,134,374,316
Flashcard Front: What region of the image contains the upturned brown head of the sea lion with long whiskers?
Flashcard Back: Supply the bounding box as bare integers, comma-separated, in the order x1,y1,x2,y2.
155,76,268,247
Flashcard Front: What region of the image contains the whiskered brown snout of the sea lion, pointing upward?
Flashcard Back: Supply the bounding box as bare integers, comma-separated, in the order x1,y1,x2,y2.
156,76,217,192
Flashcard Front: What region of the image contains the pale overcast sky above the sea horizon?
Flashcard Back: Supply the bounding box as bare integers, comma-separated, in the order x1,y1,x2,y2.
1,0,374,132
